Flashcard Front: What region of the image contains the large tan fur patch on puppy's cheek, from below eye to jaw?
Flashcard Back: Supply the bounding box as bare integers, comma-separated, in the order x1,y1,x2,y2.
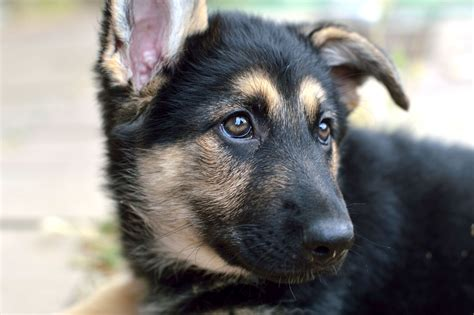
137,142,247,275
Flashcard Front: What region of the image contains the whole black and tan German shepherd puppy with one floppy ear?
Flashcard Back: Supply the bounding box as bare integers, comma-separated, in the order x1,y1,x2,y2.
96,0,474,314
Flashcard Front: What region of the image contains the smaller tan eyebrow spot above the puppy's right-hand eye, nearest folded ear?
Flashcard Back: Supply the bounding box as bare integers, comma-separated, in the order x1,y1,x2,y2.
299,77,326,121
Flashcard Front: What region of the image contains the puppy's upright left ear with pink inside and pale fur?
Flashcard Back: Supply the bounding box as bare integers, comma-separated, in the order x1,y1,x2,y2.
99,0,207,91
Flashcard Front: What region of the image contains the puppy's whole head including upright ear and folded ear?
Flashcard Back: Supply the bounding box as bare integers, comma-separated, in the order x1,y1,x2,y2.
97,0,408,281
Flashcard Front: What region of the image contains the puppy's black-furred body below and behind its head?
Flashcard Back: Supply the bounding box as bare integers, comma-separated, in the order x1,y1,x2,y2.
134,130,474,315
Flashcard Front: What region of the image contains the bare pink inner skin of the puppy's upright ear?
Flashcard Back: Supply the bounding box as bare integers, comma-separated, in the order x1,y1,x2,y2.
129,0,170,90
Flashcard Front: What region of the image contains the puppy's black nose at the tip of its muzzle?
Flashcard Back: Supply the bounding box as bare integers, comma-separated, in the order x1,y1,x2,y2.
303,219,354,264
